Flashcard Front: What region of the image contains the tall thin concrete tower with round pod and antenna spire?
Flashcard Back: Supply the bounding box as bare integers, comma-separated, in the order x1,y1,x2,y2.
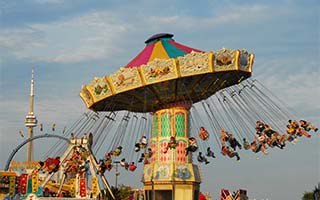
25,67,37,162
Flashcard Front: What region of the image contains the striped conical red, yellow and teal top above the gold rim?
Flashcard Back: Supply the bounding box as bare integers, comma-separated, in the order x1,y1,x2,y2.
126,33,203,68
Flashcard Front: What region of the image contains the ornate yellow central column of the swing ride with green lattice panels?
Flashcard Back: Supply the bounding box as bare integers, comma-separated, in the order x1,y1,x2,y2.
142,102,201,200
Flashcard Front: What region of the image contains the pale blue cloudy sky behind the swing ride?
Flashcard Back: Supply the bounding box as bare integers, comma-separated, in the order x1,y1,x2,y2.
0,0,320,200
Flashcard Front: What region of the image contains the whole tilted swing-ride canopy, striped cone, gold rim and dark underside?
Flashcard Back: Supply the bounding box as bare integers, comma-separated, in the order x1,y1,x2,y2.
80,33,254,112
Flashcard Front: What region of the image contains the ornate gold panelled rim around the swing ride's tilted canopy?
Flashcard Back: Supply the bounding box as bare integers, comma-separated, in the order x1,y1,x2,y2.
80,48,254,108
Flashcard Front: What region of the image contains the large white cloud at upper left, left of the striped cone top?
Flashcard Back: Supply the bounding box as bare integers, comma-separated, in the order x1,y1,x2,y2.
0,12,129,63
